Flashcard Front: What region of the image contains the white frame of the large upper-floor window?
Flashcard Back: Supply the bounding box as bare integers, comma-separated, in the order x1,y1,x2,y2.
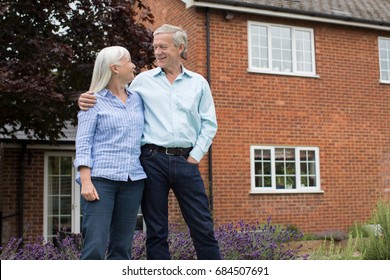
248,21,318,78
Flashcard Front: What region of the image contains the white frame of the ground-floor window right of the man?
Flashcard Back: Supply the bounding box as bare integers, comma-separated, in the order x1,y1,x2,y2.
250,145,323,194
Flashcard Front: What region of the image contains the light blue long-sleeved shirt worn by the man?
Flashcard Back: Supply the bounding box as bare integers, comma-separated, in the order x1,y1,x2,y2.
130,66,217,162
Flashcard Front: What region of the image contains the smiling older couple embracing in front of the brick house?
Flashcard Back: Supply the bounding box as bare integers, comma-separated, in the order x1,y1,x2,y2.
74,24,221,260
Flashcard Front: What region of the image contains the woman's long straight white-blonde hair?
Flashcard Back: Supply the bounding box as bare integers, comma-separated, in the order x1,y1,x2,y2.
89,46,130,93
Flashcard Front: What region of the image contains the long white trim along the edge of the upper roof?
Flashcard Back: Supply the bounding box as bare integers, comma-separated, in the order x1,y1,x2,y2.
187,0,390,31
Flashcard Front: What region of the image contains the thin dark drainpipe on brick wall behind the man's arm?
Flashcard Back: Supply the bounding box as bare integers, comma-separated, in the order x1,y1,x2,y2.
206,8,214,215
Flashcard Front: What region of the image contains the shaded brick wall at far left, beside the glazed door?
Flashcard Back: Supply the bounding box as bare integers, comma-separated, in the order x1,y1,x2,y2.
0,148,62,244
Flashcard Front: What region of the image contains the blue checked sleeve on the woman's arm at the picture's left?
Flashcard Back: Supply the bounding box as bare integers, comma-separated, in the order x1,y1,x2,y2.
73,108,98,170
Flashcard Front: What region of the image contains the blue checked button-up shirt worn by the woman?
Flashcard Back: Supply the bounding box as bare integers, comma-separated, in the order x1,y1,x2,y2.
74,89,146,183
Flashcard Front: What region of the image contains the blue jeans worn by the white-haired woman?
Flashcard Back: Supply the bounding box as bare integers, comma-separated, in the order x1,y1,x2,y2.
81,177,144,260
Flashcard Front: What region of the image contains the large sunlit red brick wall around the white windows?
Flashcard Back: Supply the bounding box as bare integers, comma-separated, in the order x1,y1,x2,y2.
144,0,390,232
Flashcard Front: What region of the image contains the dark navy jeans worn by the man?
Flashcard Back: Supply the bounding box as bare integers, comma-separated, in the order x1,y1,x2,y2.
141,148,221,260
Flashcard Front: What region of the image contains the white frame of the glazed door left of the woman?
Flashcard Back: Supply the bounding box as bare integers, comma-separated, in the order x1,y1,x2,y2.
43,151,81,241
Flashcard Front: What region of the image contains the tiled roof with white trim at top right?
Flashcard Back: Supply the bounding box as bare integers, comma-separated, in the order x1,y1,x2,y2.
182,0,390,30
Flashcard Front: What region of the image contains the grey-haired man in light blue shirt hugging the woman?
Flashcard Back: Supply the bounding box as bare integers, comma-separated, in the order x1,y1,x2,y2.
79,24,221,260
